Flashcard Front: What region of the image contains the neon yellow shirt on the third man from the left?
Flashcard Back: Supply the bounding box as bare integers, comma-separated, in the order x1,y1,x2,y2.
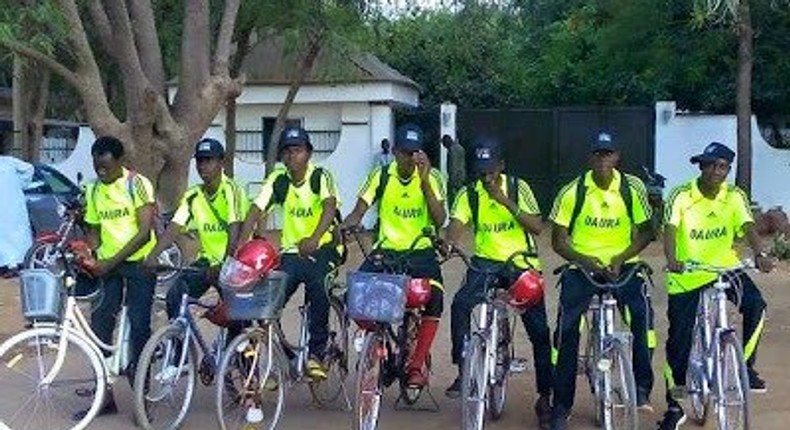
254,163,340,253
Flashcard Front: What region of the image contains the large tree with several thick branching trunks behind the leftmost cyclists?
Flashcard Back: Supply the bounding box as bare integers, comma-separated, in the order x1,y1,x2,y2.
0,0,241,209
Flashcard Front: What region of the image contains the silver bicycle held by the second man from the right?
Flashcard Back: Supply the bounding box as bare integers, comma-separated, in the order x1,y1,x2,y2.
554,262,652,430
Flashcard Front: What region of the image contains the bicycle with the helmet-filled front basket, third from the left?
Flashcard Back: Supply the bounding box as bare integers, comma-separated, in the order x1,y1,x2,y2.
216,250,350,430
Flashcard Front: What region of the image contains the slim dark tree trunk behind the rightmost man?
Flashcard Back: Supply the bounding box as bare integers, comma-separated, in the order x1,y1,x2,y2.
735,0,754,196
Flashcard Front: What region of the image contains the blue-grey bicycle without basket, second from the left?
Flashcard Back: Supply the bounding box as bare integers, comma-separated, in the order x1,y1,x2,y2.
134,266,228,430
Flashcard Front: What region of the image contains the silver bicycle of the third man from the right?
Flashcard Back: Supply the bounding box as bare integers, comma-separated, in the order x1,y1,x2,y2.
451,248,537,430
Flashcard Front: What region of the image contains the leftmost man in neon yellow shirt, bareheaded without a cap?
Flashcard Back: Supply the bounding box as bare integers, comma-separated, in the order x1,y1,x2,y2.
78,136,156,413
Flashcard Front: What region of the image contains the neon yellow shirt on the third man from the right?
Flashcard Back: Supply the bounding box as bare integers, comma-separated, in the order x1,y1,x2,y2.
451,174,540,269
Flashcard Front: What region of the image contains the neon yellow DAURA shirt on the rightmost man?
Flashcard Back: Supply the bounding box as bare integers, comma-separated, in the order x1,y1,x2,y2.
664,179,754,294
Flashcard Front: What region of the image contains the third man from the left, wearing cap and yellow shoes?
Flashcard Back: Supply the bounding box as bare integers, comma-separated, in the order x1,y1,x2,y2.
239,127,340,379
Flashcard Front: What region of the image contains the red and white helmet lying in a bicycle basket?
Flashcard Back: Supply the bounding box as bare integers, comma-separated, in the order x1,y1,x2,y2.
219,239,280,288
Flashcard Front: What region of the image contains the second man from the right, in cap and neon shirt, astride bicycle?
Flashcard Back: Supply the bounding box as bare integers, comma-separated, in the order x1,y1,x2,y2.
549,132,654,430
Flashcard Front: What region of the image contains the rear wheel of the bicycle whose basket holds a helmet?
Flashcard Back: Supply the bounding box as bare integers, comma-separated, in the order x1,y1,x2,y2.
310,297,348,406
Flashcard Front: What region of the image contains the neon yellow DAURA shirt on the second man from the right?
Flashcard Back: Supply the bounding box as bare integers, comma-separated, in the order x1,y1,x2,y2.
549,170,652,265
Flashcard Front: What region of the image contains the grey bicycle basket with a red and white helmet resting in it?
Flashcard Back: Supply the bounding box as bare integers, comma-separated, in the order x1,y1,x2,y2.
220,270,288,321
